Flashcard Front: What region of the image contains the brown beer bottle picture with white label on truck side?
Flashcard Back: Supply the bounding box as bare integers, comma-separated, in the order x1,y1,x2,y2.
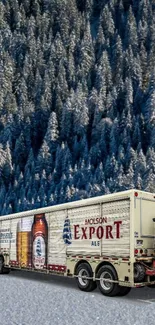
32,214,48,269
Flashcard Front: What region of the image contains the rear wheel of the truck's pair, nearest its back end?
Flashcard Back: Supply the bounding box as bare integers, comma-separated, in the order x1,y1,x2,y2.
97,265,120,297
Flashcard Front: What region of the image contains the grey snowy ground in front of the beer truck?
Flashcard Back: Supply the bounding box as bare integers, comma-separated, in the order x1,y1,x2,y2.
0,271,155,325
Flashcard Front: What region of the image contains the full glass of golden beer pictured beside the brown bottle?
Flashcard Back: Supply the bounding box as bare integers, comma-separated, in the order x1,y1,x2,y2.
16,217,32,267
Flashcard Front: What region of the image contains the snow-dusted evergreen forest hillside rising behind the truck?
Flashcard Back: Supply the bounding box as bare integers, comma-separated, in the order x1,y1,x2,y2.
0,0,155,215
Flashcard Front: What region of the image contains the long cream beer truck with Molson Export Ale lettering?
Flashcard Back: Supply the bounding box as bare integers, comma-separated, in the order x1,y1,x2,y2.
0,189,155,297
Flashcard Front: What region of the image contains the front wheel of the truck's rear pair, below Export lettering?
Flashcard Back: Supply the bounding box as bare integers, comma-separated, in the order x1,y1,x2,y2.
76,263,97,292
